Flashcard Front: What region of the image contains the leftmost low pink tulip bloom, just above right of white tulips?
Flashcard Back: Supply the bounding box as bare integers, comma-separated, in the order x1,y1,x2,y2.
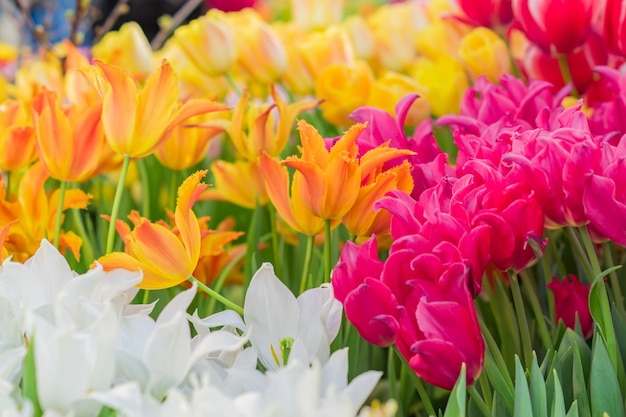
331,236,399,347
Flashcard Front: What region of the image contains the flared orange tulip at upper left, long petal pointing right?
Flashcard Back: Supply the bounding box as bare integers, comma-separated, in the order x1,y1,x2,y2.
96,60,228,158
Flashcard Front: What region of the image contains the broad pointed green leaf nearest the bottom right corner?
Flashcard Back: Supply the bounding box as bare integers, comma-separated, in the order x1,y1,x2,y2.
589,336,624,417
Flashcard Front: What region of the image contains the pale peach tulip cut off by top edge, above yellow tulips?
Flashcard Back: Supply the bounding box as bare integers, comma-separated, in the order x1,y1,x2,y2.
291,0,344,30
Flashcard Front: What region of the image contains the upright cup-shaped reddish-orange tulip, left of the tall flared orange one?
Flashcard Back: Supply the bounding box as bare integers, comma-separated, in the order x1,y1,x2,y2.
32,87,105,182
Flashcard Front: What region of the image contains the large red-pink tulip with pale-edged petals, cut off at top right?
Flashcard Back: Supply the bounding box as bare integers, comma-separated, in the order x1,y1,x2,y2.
513,0,599,54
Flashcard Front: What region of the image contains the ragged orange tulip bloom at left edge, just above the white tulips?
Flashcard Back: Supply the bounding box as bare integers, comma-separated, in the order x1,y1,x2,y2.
0,162,91,262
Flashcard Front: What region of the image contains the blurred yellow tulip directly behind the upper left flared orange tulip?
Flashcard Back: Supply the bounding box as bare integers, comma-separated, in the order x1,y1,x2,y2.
91,22,155,80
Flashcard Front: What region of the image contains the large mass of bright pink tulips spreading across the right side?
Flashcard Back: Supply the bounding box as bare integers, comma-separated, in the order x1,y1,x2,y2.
332,57,626,389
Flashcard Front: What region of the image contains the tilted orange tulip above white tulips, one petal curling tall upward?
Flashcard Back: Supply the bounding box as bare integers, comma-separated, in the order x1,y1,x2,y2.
98,170,207,289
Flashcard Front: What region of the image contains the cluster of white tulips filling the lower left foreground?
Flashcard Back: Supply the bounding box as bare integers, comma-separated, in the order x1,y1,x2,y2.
0,240,381,417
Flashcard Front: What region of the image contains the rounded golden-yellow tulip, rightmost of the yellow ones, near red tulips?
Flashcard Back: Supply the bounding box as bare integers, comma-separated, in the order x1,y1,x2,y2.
459,27,511,83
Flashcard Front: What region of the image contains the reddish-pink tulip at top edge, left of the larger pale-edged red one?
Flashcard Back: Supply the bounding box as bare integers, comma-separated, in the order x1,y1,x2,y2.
452,0,513,30
